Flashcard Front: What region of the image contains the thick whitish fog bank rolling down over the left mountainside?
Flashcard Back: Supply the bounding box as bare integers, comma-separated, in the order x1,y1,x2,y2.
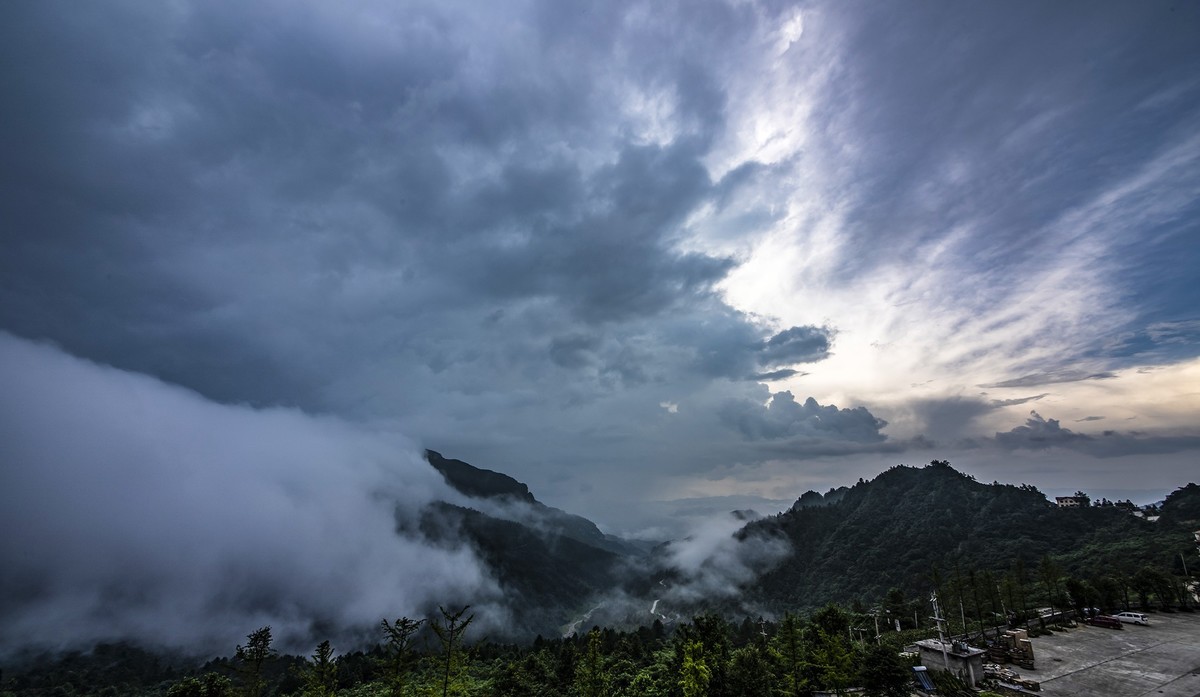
0,332,505,653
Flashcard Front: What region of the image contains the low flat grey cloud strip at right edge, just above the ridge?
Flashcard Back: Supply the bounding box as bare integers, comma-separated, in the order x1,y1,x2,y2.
996,411,1200,457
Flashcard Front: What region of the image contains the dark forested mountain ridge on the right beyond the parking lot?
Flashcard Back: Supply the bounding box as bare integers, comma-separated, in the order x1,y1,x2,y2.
740,461,1200,609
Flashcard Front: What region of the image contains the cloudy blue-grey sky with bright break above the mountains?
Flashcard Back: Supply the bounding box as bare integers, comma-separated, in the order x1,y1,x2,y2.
0,0,1200,549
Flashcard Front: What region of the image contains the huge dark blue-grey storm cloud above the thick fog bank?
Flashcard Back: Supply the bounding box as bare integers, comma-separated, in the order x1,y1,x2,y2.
0,4,828,415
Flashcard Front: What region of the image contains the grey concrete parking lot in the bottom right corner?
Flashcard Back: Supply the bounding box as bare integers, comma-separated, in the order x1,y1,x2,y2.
1020,613,1200,697
